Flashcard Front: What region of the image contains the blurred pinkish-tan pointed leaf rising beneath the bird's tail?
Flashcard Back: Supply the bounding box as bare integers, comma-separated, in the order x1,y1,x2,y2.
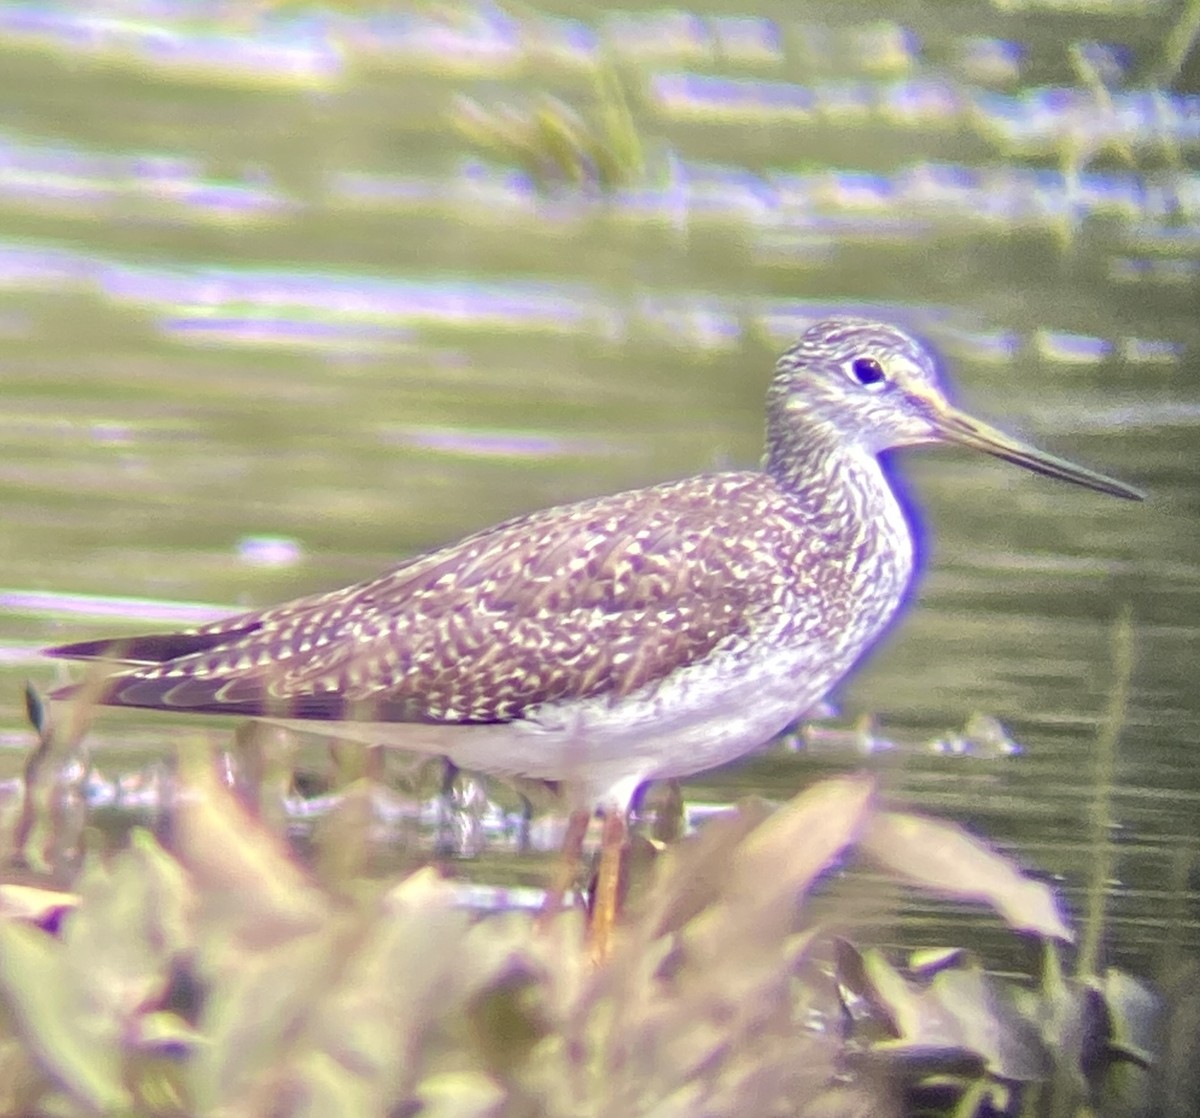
173,757,329,949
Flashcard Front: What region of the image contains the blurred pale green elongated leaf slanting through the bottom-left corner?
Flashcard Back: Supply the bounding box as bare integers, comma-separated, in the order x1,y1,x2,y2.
0,922,131,1112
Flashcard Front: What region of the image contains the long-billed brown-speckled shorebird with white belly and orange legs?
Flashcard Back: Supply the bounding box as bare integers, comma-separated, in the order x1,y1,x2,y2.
48,317,1142,950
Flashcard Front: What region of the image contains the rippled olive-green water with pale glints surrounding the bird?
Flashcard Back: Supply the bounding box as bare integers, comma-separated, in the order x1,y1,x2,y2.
0,0,1200,978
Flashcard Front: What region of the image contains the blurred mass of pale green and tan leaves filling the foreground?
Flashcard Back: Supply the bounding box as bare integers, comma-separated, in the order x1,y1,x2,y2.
0,701,1156,1118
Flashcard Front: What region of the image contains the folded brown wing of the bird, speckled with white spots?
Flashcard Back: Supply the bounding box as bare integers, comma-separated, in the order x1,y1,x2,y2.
54,474,816,722
